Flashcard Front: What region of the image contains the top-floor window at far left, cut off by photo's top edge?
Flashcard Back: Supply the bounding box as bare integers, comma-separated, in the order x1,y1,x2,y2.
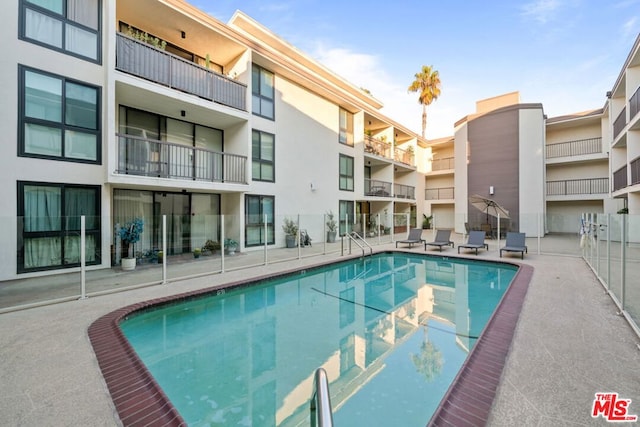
20,0,101,62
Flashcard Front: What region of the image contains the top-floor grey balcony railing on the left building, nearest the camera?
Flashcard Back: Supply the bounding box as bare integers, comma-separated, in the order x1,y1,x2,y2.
116,34,247,111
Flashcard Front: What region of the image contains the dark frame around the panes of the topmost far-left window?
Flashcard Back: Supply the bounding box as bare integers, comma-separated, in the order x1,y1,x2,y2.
18,0,103,65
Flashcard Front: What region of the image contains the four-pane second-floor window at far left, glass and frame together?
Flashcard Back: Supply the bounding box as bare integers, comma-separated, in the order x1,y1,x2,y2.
19,67,101,163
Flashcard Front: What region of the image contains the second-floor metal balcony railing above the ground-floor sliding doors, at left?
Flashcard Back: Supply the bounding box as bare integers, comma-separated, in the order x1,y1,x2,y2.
116,134,247,184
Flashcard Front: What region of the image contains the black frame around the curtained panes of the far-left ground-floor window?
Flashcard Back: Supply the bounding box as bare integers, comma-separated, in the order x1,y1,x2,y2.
16,181,102,274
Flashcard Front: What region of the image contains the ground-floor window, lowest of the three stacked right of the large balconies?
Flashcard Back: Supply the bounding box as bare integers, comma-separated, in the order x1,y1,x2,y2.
245,195,275,247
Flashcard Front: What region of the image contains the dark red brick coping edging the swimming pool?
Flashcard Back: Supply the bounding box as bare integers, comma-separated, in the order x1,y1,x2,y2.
88,252,533,426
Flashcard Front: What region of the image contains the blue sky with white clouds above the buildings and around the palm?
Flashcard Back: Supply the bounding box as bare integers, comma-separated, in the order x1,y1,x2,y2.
187,0,640,138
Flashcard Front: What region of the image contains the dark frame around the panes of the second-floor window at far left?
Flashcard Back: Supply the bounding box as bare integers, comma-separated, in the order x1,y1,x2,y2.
18,65,102,165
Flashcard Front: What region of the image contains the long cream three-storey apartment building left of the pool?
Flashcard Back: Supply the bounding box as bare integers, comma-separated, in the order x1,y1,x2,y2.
0,0,426,280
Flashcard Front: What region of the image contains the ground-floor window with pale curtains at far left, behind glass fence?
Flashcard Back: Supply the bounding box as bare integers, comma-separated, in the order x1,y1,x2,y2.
18,182,101,273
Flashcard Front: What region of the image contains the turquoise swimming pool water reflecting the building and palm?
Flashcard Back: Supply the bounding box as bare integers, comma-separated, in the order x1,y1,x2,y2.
121,253,517,426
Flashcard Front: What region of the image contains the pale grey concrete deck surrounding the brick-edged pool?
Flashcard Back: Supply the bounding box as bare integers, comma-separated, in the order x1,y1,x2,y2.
0,239,640,426
